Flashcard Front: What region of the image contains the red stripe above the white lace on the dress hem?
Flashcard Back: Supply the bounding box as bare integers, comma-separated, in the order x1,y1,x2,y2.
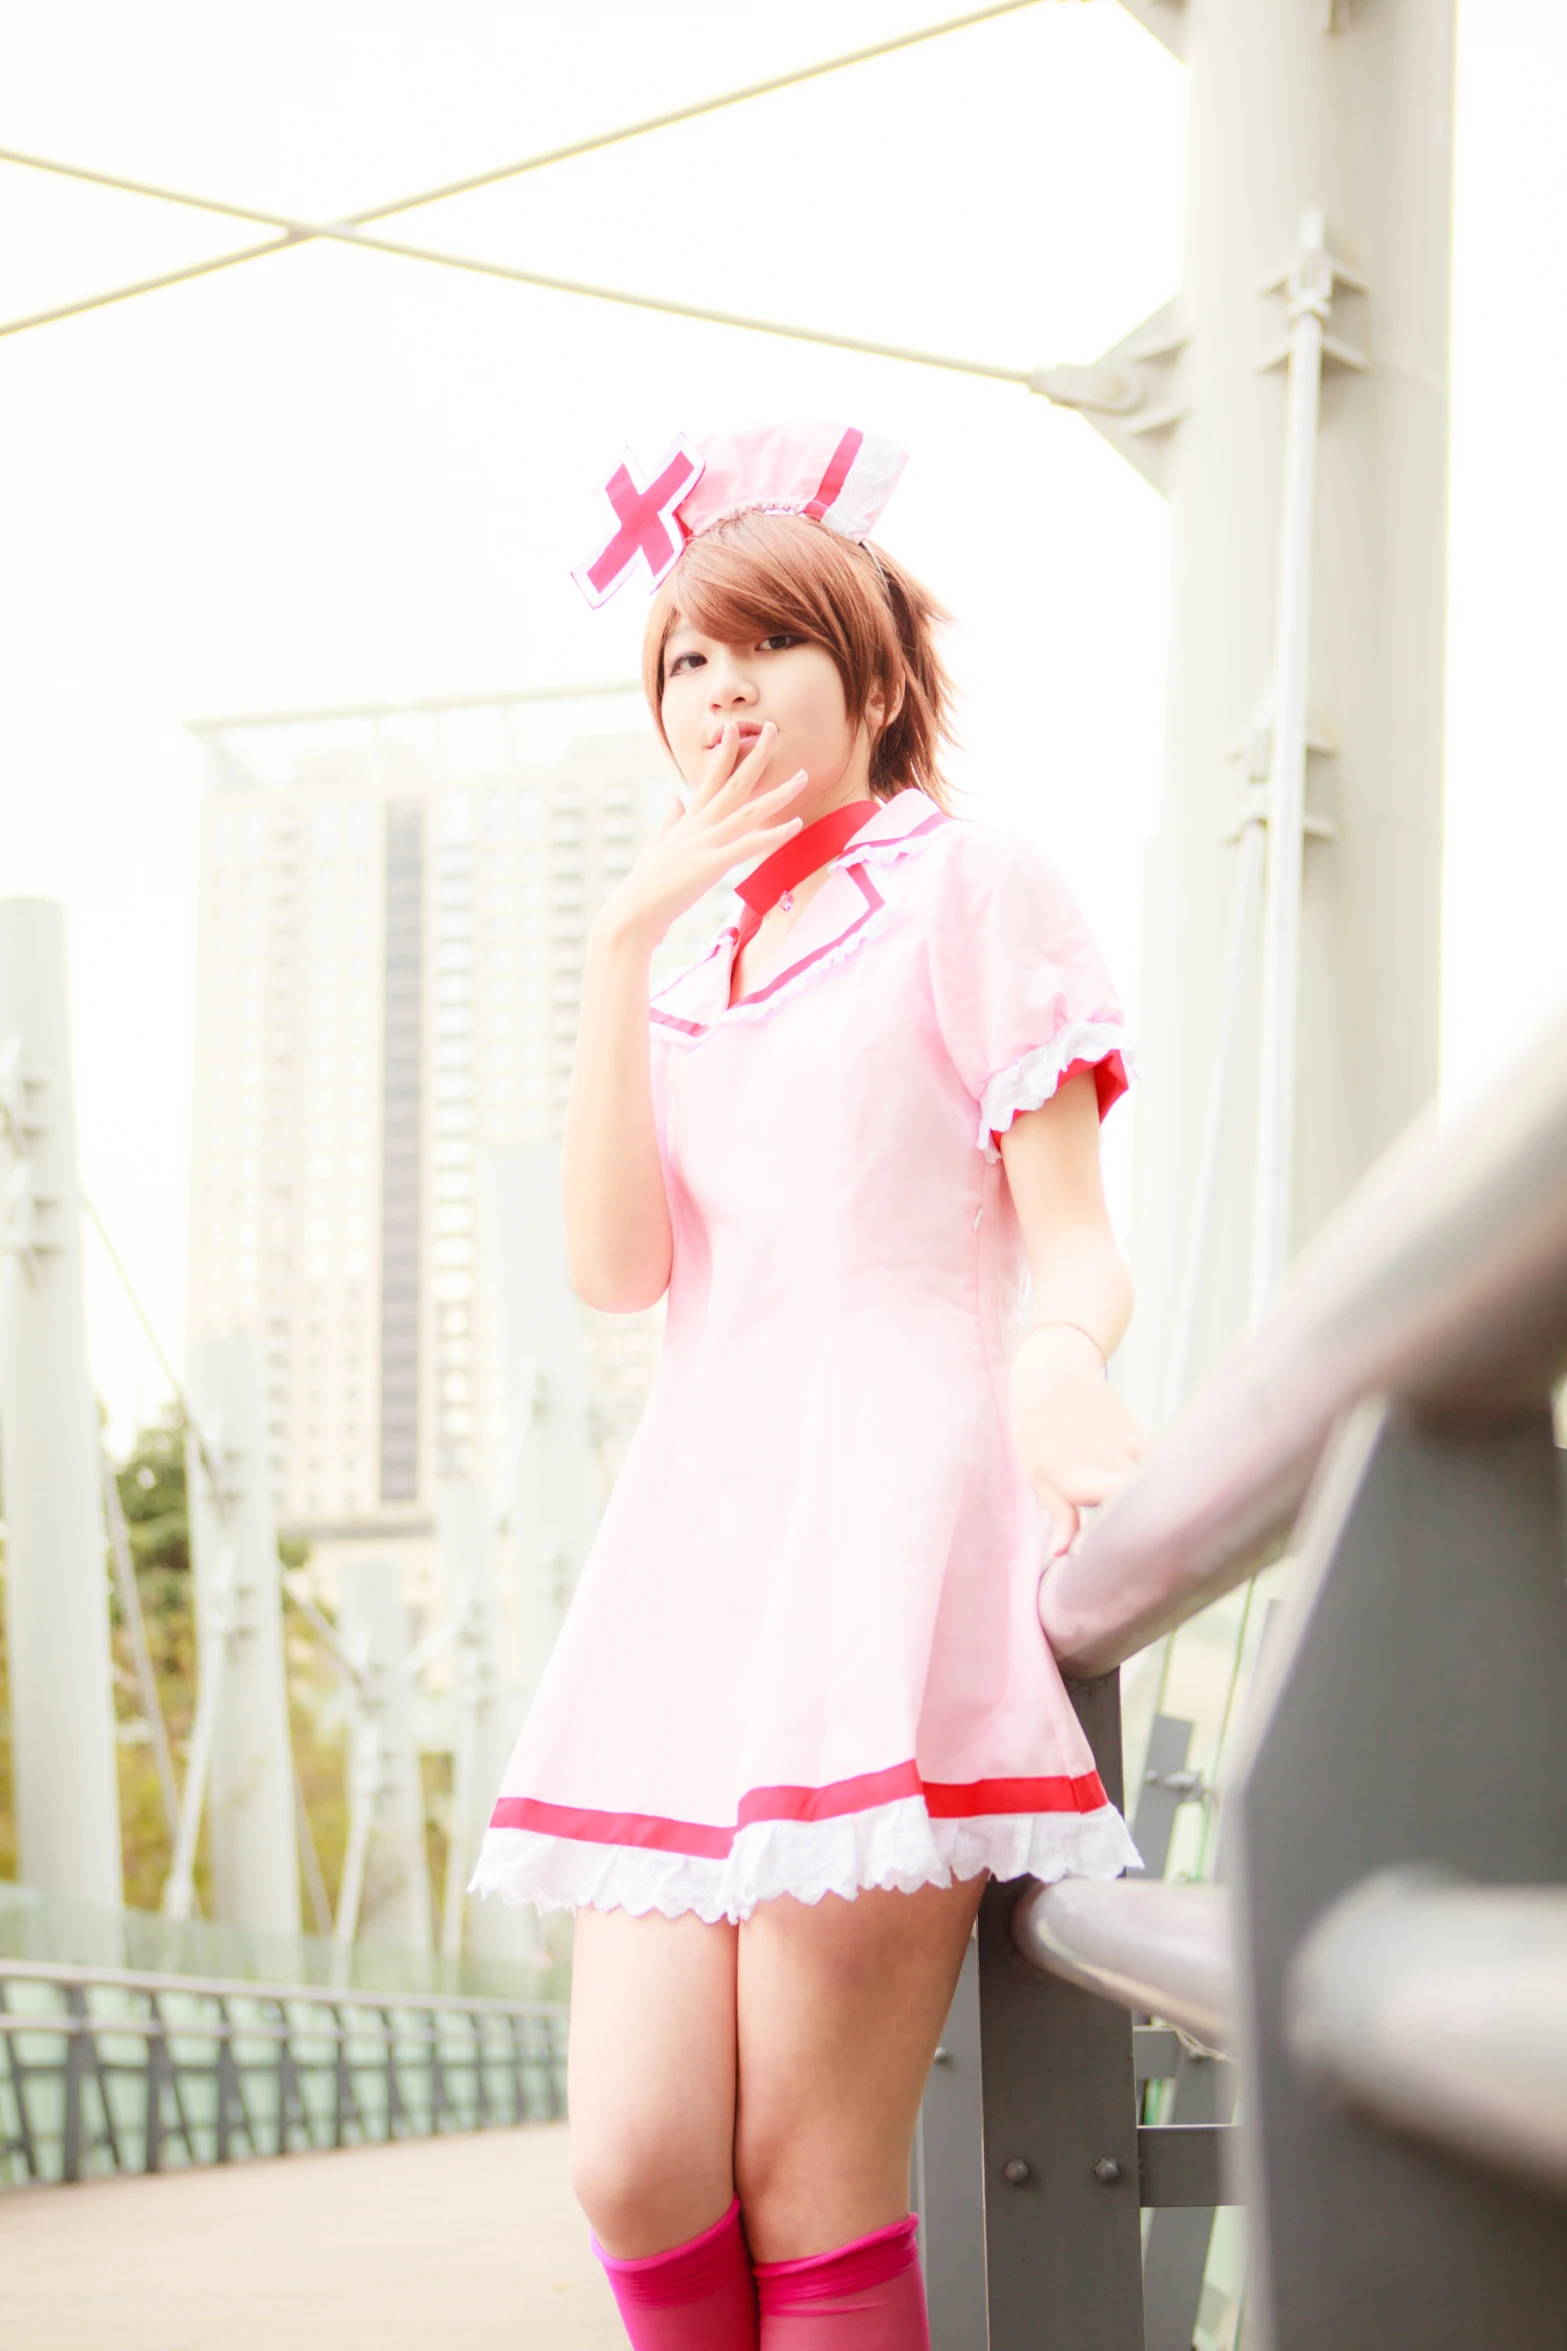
489,1763,1109,1862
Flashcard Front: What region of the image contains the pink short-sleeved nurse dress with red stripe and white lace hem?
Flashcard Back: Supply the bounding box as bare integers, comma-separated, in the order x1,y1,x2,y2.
475,790,1137,1921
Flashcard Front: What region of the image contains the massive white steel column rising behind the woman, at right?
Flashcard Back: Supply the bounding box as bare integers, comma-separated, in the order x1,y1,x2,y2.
1104,0,1454,1415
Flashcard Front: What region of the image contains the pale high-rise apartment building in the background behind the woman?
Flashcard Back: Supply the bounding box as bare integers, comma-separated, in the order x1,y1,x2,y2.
190,698,690,1579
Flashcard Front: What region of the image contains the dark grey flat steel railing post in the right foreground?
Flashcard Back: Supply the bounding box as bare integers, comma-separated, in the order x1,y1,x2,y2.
1226,1401,1567,2351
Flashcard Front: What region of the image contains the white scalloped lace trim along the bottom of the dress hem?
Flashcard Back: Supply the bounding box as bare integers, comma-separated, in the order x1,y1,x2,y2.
468,1796,1142,1925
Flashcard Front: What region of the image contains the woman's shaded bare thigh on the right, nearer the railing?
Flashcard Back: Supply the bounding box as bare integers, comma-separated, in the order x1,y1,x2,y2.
735,1878,984,2262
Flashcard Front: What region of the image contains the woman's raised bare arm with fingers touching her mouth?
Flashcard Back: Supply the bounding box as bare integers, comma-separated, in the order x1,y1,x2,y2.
561,726,806,1314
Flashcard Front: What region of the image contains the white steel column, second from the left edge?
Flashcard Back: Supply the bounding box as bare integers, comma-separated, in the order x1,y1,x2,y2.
179,1338,301,1935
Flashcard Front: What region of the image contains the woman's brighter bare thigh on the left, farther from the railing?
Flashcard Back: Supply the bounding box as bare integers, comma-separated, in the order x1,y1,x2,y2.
566,1909,735,2259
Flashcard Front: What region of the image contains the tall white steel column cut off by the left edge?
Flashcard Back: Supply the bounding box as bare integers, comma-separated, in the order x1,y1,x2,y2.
0,898,122,1909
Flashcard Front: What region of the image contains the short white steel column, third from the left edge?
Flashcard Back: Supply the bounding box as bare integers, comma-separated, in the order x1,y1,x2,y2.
336,1559,430,1951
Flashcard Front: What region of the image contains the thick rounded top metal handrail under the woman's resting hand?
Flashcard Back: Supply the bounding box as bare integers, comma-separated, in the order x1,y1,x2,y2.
1038,1020,1567,1676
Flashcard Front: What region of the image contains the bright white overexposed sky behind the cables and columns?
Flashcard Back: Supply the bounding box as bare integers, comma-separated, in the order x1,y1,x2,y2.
0,0,1567,1432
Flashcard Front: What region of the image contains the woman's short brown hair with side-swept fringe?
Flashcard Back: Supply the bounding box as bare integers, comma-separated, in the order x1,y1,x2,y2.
641,513,951,806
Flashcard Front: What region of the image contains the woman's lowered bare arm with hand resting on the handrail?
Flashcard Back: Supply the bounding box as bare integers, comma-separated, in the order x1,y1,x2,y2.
1001,1072,1142,1549
